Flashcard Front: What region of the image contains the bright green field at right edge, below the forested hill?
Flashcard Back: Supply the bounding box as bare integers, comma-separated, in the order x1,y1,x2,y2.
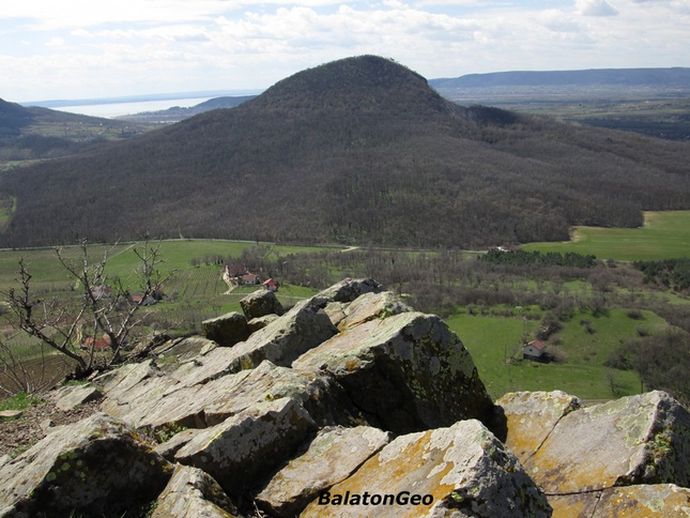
522,210,690,261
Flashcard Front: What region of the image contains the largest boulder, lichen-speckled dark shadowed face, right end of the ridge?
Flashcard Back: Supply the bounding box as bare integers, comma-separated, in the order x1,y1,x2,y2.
293,312,493,433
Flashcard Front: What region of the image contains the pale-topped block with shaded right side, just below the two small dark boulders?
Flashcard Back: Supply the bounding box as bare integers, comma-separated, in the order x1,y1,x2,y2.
223,299,337,370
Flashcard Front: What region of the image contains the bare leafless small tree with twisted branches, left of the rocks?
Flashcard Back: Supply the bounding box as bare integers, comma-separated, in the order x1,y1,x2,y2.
7,241,171,376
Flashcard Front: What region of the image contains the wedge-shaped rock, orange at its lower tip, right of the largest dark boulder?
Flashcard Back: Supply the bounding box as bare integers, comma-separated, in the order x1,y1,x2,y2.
496,390,580,464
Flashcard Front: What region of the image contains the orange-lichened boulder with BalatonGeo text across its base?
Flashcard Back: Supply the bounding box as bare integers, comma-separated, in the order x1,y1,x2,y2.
300,420,551,518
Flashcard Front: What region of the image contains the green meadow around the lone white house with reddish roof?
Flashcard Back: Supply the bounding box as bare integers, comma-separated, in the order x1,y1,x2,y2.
447,309,652,400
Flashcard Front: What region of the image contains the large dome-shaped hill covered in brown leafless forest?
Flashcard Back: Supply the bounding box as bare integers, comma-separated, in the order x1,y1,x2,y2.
0,56,690,247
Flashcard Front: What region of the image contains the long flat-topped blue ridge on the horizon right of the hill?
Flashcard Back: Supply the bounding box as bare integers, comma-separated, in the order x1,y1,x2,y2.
429,67,690,89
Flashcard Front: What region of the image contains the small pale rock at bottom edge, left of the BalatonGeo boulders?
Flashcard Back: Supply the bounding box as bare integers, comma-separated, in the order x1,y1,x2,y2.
151,465,237,518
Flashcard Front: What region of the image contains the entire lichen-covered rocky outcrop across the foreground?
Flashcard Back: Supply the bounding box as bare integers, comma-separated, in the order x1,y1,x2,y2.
0,279,690,518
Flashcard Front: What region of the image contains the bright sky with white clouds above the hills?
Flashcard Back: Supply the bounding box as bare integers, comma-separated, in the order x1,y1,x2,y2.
0,0,690,102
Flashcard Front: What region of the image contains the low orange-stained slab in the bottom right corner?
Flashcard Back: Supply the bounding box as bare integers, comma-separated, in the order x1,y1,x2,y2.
549,484,690,518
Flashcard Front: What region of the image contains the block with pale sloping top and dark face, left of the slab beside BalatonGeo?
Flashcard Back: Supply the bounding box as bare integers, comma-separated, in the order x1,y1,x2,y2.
175,398,316,496
